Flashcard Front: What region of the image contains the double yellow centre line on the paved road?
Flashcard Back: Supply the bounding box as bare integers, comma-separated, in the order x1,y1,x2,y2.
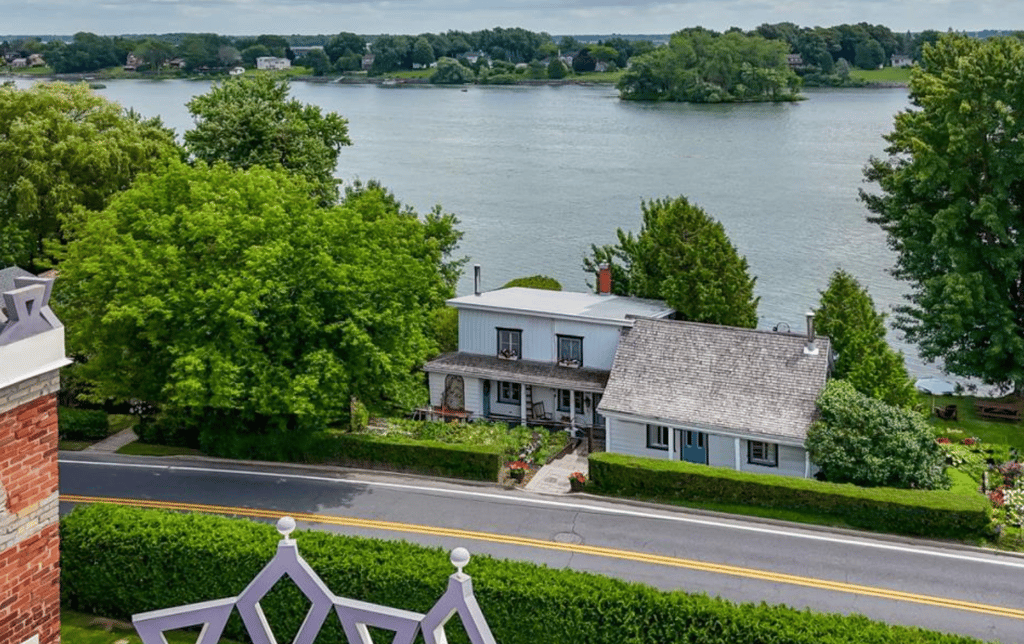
60,495,1024,619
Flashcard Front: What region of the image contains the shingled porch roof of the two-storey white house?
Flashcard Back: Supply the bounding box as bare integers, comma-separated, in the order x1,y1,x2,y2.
423,352,608,392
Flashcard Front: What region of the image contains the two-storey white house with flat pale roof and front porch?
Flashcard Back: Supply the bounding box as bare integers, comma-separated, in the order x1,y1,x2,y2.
424,264,673,428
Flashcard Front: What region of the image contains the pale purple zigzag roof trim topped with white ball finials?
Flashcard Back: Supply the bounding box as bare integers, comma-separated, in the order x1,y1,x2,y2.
132,517,495,644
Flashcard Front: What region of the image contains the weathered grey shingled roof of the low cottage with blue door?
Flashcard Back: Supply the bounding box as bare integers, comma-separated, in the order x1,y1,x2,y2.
598,319,831,441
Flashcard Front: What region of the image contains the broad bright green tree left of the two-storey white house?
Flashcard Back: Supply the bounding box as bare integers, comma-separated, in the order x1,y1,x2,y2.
57,162,460,454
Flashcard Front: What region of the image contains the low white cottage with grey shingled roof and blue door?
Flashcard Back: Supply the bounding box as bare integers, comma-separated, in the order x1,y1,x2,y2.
597,315,831,477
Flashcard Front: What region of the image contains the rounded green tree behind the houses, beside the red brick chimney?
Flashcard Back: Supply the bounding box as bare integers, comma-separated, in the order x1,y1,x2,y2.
584,197,760,329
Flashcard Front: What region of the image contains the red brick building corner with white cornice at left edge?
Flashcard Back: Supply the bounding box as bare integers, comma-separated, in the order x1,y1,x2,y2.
0,268,70,644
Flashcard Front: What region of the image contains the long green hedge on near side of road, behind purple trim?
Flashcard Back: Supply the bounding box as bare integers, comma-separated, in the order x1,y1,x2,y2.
60,506,978,644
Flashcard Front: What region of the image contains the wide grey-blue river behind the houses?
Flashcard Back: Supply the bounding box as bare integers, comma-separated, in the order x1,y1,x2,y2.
8,80,938,377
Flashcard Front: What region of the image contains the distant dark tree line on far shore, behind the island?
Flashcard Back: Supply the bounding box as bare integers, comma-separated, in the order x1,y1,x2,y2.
0,23,939,77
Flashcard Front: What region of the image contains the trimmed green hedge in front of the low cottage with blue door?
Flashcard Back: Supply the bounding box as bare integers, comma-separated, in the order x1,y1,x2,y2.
590,454,990,539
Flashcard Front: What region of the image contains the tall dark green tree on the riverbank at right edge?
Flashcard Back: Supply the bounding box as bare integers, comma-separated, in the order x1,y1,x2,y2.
861,35,1024,392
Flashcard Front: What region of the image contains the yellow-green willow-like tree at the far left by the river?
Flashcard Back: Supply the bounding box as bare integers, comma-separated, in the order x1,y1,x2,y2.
0,83,181,269
